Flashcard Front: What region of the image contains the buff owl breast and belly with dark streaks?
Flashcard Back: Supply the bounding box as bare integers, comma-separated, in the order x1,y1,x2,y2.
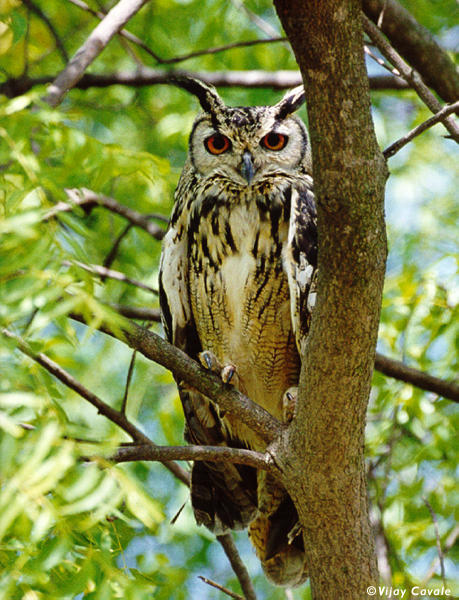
188,176,299,450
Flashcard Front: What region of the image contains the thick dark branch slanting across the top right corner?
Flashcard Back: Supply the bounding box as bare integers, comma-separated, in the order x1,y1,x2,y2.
362,0,459,103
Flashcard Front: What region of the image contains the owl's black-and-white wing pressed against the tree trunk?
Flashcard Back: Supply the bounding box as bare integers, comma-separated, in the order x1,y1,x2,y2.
284,176,317,356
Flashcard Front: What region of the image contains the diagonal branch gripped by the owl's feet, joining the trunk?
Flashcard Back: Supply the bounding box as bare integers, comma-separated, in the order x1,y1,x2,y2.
69,313,283,443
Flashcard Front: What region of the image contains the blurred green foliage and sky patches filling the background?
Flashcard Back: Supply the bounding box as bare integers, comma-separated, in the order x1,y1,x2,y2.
0,0,458,600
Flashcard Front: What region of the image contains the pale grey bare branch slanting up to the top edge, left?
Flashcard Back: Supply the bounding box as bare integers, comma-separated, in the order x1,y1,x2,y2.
45,0,148,107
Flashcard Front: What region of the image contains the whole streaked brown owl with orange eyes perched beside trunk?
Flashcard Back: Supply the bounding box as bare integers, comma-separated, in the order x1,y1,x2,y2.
159,77,317,587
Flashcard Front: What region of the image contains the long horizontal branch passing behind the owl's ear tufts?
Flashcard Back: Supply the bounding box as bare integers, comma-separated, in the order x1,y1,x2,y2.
0,67,409,98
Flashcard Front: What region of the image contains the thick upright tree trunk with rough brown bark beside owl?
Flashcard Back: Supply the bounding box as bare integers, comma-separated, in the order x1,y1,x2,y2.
273,0,387,600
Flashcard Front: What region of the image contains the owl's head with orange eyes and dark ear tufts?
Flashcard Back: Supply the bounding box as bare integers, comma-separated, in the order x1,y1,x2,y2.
171,76,310,186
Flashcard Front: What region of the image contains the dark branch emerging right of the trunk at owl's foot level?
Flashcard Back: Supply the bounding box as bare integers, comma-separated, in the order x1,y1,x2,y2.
375,353,459,402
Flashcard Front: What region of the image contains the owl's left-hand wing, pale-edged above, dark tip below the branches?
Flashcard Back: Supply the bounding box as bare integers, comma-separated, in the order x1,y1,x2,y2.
159,224,257,534
